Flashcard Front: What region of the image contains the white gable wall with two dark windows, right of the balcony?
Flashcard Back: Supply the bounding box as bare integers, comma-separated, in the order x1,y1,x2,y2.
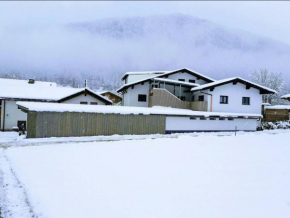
204,83,262,114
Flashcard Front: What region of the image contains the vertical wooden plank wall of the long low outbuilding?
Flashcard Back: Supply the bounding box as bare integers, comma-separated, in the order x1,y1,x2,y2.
27,112,165,138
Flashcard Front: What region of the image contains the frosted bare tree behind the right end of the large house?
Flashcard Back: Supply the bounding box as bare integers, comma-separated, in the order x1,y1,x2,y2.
250,69,285,104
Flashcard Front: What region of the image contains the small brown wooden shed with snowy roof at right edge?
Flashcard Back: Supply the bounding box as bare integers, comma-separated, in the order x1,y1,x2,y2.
265,105,290,122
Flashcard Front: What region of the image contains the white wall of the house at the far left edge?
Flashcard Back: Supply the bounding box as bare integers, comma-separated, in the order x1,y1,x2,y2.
1,100,27,131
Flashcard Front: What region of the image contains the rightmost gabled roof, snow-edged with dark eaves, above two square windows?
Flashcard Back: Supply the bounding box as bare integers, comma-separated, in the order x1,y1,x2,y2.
191,77,276,94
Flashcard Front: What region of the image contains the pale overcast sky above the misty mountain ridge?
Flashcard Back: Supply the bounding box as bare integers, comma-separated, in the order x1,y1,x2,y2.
0,1,290,44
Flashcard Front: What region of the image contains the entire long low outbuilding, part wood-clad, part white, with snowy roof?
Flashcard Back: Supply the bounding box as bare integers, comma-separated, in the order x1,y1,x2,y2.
17,102,262,138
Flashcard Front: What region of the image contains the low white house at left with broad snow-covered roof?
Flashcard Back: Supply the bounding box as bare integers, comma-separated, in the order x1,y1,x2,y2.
0,79,112,131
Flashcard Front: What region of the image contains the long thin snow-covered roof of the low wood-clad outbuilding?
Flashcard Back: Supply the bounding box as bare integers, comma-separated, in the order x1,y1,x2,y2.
17,102,262,118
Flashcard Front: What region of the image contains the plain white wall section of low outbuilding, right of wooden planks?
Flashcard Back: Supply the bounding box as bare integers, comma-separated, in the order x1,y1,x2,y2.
166,117,258,131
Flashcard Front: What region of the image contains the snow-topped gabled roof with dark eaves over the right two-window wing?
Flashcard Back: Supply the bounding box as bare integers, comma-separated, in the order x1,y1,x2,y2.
191,77,277,94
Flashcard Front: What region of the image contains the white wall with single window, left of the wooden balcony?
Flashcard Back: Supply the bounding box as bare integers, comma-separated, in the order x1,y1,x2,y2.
123,82,150,107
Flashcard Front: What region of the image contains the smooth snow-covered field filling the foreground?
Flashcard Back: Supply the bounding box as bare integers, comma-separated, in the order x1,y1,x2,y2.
0,130,290,218
